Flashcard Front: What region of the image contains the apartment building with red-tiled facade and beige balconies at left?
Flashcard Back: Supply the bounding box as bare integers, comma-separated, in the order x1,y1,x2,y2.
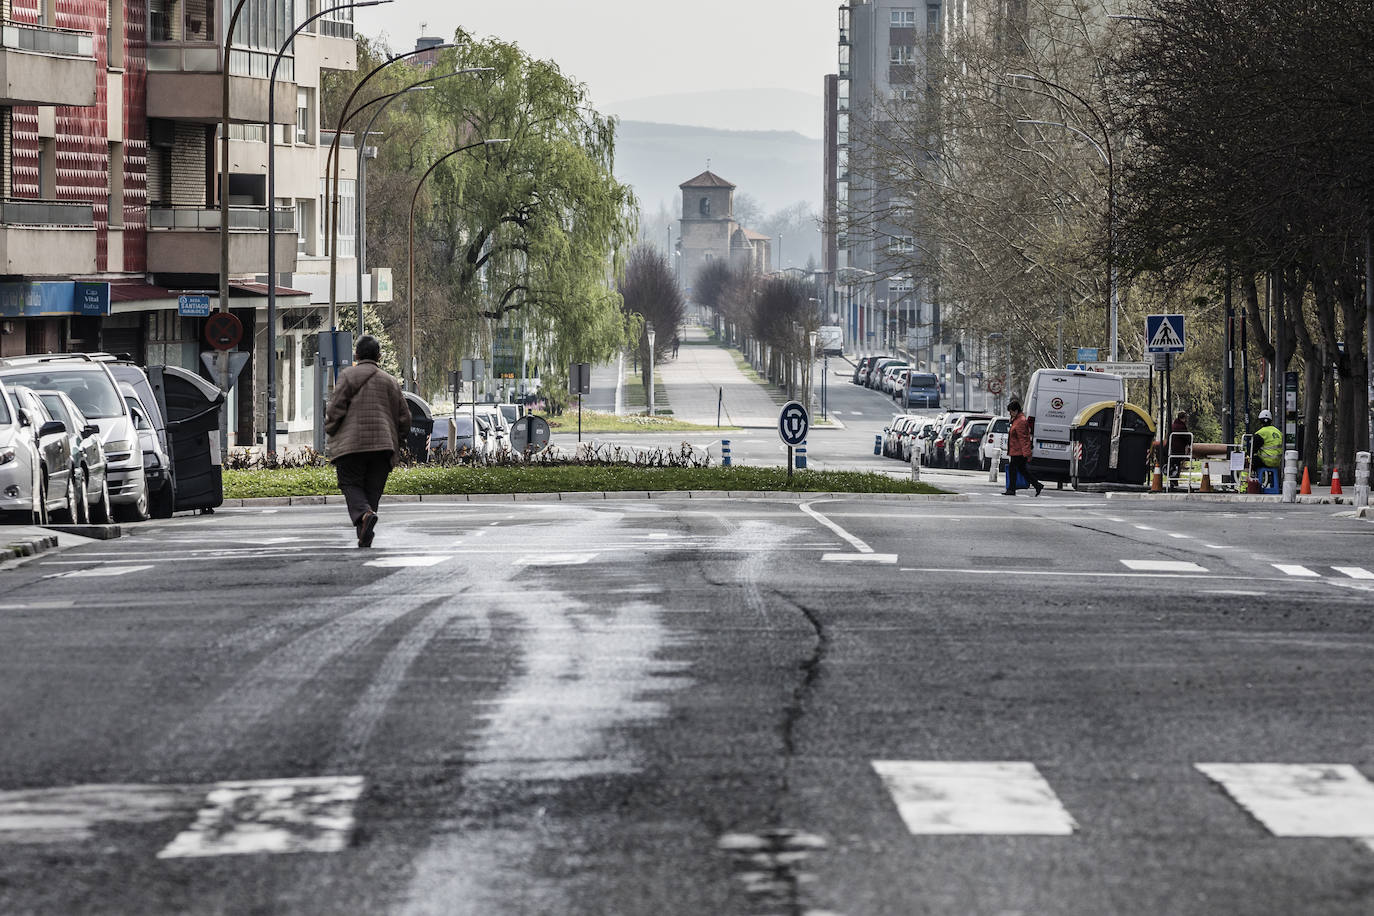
0,0,372,444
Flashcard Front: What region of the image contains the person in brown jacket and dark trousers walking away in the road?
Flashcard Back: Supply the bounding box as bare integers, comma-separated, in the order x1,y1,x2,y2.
324,334,411,547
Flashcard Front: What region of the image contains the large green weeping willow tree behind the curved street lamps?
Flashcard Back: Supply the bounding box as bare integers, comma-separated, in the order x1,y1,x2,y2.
326,30,638,398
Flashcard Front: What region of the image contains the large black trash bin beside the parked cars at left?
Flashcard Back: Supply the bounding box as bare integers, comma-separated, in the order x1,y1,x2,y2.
148,365,224,512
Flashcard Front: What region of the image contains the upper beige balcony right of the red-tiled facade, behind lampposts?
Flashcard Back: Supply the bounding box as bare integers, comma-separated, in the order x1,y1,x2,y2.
148,41,295,124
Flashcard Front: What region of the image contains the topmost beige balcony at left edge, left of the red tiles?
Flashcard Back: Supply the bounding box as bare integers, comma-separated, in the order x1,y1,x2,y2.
0,21,95,106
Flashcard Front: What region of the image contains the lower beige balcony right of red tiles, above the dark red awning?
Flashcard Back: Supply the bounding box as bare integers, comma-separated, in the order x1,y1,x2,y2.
148,207,295,275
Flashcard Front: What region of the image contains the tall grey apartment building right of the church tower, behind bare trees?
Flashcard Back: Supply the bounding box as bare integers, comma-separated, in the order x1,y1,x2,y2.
822,0,941,352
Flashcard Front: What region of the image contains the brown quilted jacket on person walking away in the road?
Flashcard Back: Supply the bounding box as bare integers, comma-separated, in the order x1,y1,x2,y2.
324,360,411,467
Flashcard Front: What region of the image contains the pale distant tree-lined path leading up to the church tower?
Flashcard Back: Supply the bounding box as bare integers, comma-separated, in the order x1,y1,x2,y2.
654,327,778,427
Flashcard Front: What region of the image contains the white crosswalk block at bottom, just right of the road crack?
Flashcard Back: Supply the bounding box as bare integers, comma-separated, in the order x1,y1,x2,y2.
872,761,1076,836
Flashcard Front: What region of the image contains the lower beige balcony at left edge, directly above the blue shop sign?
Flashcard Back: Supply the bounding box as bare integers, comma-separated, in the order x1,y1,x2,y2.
0,201,95,276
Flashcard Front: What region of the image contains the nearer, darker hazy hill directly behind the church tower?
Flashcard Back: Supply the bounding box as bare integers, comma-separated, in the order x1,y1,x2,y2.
616,121,822,213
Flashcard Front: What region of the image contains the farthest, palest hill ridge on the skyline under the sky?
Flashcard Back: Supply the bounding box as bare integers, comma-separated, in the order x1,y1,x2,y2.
598,89,824,137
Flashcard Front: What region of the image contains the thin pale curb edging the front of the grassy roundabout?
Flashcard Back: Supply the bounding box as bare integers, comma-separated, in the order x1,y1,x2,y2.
224,490,969,509
